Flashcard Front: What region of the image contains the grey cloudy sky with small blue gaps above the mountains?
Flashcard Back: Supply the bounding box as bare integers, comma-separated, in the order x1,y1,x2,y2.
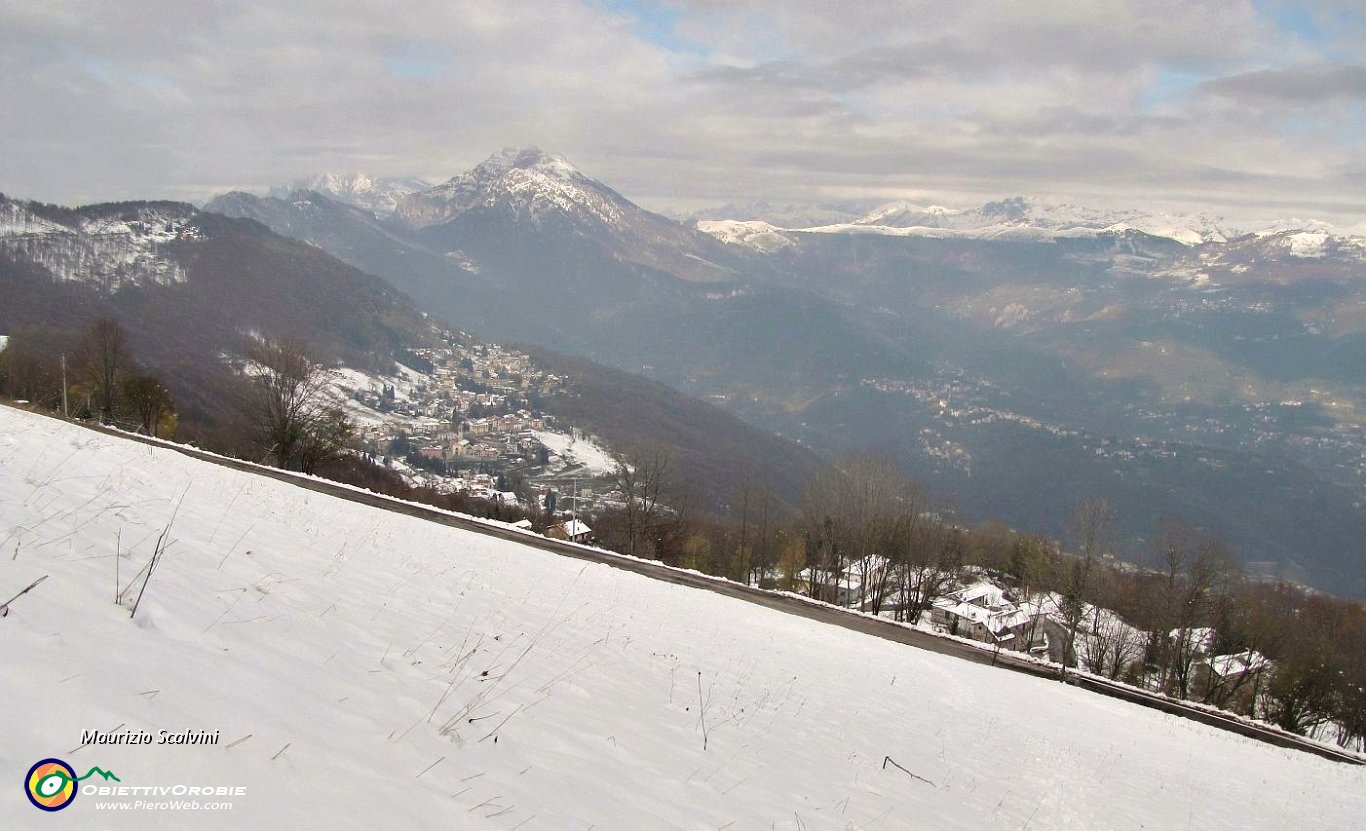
0,0,1366,226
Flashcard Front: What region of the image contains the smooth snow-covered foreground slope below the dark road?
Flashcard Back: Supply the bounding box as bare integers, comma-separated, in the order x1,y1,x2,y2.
0,409,1366,830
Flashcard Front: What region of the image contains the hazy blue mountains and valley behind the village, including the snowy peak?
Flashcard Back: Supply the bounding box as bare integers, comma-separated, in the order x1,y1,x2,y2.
199,149,1366,596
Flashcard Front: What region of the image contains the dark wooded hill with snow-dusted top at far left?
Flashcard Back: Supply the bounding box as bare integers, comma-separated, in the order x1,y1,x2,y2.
0,195,433,444
